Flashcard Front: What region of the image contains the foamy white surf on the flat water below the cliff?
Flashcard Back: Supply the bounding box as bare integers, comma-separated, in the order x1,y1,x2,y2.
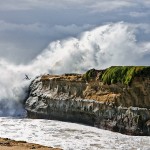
0,118,150,150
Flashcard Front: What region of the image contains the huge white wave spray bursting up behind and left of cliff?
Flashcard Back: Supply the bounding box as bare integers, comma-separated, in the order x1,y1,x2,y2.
0,23,150,116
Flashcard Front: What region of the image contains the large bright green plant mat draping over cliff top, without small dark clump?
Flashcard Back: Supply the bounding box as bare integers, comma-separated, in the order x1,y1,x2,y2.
101,66,150,85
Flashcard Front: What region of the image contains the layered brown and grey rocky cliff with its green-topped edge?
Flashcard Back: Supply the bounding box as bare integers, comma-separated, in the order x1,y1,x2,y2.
25,67,150,135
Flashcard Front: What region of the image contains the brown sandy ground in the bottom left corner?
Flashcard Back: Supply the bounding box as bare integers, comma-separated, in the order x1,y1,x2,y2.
0,138,61,150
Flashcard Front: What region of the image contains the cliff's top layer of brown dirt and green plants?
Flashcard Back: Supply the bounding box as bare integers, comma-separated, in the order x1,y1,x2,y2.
41,66,150,86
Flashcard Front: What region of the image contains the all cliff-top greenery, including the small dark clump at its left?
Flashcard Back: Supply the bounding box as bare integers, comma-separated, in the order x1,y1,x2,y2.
83,66,150,85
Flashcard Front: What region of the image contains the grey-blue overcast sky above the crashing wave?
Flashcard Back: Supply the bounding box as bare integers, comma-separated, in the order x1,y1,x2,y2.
0,0,150,63
